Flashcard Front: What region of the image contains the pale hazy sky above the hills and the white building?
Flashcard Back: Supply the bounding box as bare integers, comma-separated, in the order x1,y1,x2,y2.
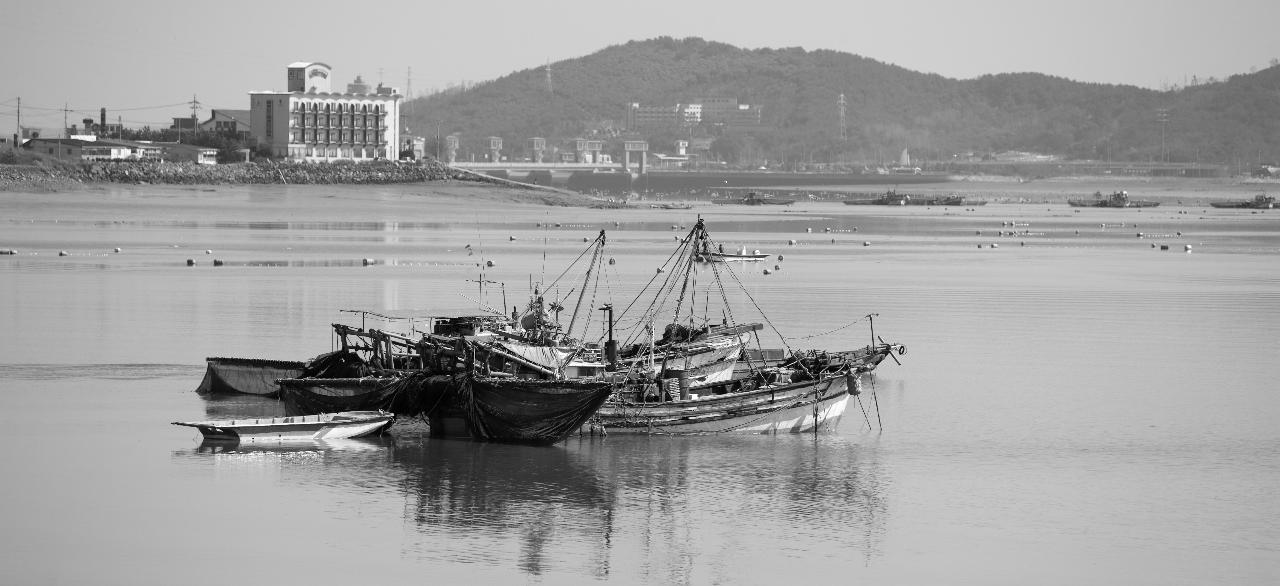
0,0,1280,136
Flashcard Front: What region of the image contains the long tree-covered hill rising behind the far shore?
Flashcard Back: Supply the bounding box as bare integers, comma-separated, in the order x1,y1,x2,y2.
403,37,1280,166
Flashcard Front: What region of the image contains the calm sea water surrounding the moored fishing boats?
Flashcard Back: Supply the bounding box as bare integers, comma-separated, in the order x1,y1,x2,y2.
0,186,1280,585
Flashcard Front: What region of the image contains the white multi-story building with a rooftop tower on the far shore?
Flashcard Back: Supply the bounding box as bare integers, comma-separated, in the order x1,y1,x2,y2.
250,63,402,162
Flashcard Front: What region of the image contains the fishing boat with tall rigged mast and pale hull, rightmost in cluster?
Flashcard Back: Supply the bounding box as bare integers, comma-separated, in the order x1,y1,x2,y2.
581,219,905,434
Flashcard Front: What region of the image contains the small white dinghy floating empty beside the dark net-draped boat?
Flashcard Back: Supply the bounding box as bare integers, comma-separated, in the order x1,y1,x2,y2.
173,411,396,441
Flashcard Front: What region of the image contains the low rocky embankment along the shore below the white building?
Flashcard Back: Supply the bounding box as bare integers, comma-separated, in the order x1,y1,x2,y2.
0,161,488,191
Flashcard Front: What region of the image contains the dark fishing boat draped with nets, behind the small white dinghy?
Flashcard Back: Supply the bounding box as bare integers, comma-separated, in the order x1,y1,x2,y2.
279,230,622,444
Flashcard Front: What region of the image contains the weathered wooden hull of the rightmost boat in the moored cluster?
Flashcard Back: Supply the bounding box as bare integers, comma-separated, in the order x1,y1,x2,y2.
584,375,849,435
